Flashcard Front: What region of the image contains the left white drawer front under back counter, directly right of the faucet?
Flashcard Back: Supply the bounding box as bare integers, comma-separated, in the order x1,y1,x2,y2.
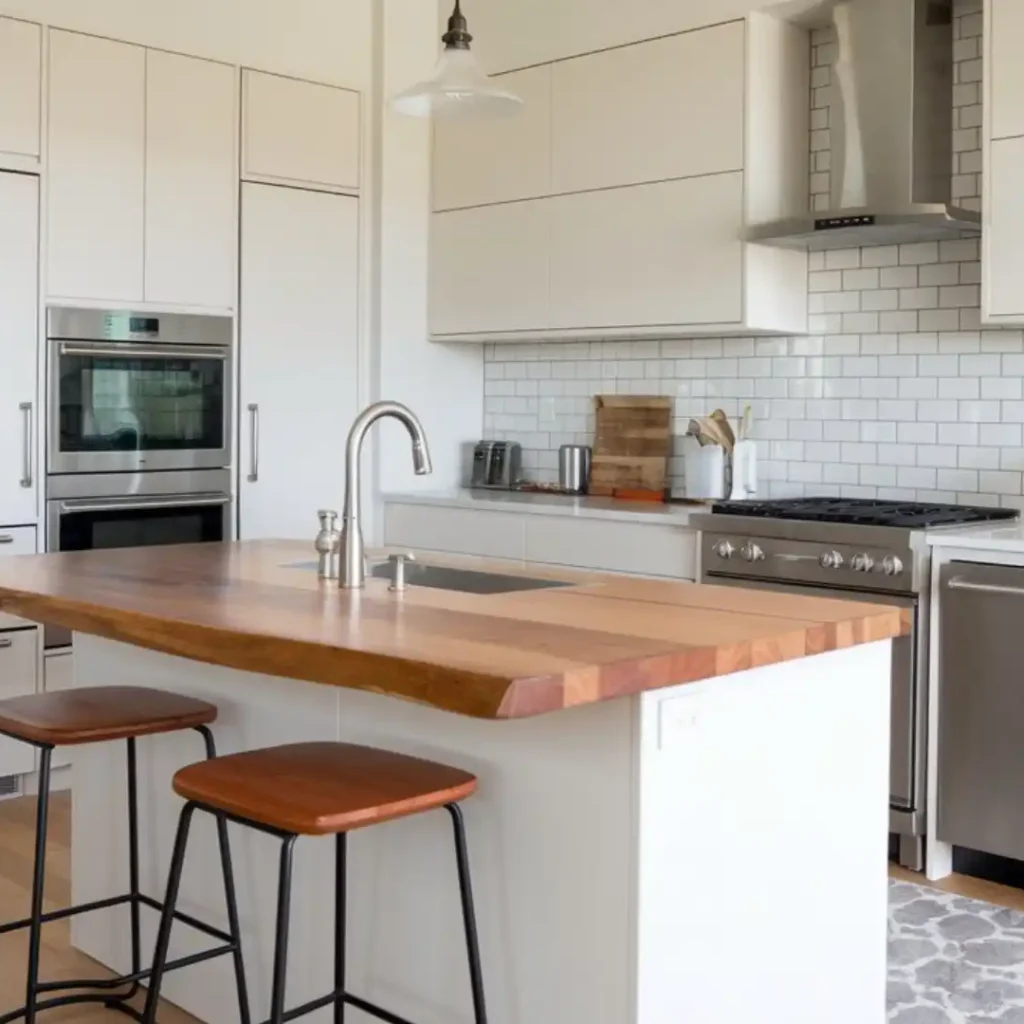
384,505,526,561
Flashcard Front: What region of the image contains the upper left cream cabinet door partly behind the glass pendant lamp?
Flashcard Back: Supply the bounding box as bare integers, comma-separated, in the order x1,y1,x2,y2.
434,66,551,210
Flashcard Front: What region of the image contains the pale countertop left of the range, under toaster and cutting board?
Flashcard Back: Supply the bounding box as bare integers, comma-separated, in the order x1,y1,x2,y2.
384,489,708,526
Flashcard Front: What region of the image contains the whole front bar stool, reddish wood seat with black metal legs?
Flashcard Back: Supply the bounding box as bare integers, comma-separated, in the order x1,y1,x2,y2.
143,742,486,1024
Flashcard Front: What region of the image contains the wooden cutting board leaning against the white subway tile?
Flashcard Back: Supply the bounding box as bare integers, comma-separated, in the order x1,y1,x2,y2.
590,394,672,497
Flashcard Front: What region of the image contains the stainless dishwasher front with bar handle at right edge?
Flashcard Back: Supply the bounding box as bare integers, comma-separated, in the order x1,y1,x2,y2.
937,562,1024,860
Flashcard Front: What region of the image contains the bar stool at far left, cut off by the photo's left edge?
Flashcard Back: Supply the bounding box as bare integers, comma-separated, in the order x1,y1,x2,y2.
0,686,245,1024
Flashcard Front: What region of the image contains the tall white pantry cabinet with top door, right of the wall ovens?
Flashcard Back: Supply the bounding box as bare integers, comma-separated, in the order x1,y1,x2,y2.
239,71,360,540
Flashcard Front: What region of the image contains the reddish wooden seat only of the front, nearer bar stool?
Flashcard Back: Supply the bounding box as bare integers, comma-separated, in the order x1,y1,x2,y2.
174,742,476,836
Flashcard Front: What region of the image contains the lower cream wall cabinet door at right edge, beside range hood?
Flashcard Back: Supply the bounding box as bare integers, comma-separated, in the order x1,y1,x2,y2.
982,138,1024,319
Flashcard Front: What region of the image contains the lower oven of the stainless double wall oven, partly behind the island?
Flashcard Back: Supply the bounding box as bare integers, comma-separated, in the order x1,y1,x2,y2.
44,493,232,648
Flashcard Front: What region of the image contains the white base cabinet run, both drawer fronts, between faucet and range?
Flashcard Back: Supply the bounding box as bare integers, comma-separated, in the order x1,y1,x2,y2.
384,502,696,581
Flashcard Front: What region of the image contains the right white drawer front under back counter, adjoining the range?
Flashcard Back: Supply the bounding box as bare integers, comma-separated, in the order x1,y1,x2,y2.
526,516,696,580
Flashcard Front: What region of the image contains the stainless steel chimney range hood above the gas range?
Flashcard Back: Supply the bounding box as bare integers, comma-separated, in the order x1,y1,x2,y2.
748,0,983,250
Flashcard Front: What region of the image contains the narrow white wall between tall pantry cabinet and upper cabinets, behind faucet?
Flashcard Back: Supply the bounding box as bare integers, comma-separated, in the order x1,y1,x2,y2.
372,0,483,503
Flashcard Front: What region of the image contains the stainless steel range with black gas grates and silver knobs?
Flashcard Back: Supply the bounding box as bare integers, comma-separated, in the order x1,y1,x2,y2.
693,498,1019,869
